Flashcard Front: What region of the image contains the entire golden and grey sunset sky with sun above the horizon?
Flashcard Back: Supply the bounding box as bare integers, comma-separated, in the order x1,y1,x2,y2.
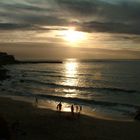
0,0,140,59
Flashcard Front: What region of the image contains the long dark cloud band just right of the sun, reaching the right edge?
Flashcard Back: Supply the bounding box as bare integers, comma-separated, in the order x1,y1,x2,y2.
79,21,140,35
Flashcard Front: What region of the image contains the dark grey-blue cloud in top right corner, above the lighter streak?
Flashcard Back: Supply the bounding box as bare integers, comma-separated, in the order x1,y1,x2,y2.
56,0,140,22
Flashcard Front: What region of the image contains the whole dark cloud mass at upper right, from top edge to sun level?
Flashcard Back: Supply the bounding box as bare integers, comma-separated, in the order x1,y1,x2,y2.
53,0,140,35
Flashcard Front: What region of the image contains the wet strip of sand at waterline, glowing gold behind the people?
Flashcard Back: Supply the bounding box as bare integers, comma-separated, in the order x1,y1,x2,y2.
0,91,135,122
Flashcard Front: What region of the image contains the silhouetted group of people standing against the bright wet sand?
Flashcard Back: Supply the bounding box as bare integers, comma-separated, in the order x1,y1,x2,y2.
56,102,82,115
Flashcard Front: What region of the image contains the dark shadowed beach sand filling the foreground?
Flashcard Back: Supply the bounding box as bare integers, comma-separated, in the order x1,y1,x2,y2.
0,98,140,140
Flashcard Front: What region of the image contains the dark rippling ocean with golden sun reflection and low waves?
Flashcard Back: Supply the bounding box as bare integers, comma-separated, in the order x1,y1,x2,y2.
0,59,140,118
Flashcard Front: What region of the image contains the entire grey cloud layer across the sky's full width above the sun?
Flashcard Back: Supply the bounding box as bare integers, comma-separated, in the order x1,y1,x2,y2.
0,0,140,35
